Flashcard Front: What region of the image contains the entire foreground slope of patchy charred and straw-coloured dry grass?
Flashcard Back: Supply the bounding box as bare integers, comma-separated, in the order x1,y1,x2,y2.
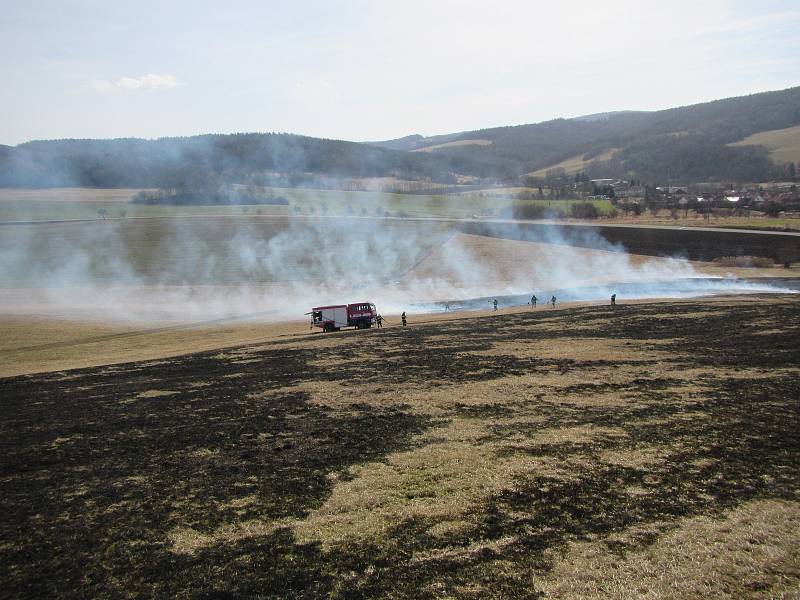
0,295,800,598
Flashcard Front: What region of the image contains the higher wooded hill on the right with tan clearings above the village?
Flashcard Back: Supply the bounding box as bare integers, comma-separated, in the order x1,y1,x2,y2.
378,87,800,182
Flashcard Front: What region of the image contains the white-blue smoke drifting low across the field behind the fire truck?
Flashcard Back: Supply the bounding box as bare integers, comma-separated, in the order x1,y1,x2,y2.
0,211,792,322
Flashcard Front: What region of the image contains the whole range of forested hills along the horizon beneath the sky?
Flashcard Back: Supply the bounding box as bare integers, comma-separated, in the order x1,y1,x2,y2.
0,87,800,187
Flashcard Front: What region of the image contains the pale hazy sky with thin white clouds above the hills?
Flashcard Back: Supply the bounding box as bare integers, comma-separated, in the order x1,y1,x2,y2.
0,0,800,145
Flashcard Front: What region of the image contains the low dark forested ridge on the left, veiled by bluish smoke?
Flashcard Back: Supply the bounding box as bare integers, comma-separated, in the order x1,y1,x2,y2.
0,133,491,187
